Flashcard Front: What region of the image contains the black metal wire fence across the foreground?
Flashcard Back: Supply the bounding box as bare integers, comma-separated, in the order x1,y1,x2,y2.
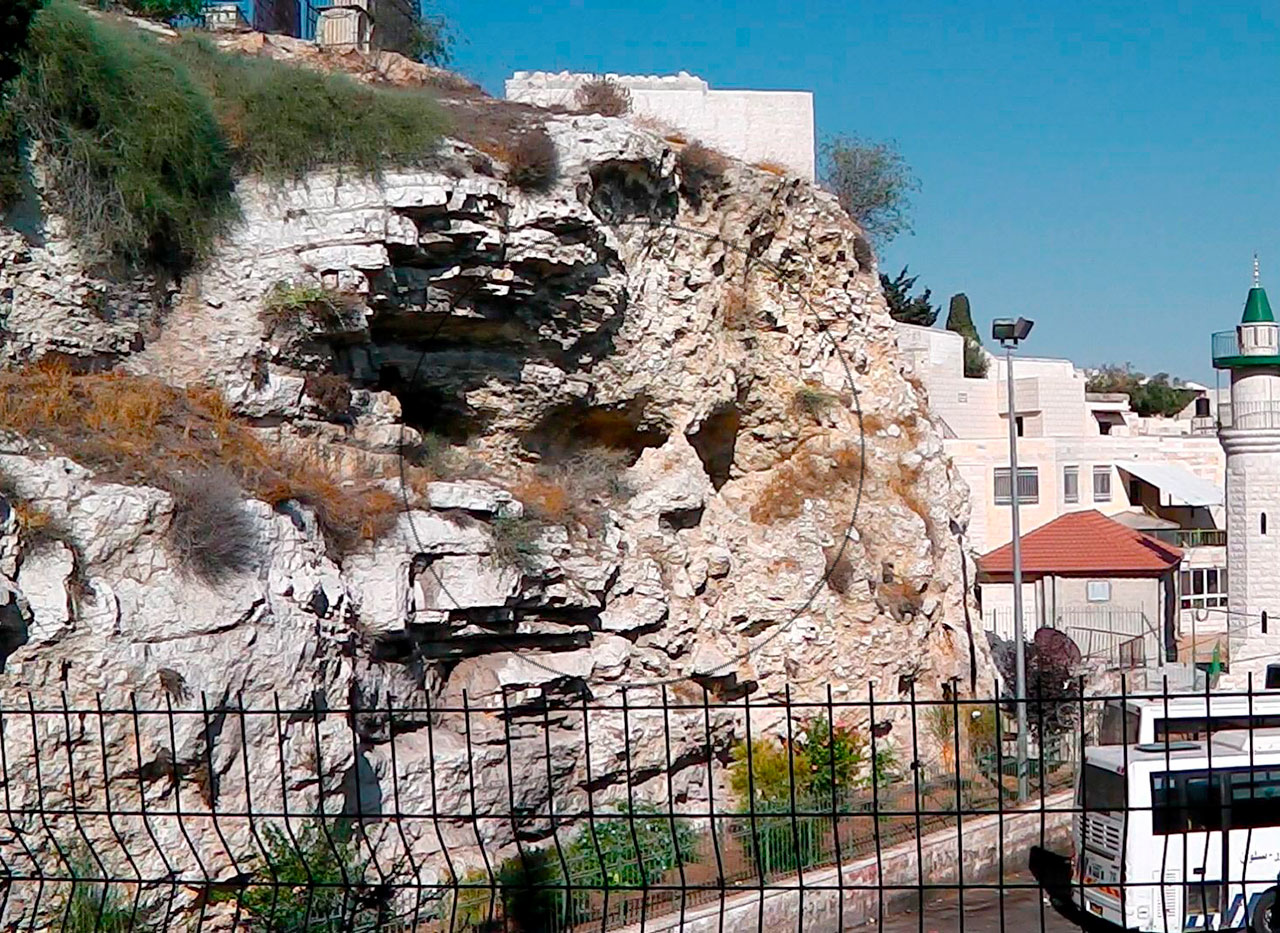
0,680,1280,933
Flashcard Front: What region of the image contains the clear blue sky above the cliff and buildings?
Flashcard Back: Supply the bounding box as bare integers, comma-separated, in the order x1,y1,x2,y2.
435,0,1280,381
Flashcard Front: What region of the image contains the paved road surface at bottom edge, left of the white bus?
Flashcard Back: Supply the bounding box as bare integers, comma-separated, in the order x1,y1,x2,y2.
863,875,1116,933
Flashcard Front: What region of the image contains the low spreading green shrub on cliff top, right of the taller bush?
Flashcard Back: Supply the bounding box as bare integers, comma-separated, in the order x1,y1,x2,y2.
174,36,444,178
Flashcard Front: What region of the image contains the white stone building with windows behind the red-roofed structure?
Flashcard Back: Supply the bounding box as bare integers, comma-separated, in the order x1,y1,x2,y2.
896,324,1228,650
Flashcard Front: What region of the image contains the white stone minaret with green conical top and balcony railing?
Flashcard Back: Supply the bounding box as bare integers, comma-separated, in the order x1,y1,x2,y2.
1213,255,1280,660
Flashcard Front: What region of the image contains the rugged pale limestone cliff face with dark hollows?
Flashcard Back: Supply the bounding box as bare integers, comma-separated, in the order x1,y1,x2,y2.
0,90,991,921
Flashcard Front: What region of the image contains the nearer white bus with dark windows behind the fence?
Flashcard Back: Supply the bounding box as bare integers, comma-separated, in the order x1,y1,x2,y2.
1073,730,1280,933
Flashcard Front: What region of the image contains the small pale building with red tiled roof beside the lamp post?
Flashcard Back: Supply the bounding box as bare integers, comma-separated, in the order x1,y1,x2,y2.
978,509,1183,660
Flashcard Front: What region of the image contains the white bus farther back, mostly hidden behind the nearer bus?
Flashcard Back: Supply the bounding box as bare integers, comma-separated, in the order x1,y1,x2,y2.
1098,692,1280,745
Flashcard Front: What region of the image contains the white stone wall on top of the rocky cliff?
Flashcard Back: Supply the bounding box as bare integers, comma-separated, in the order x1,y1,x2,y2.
504,72,815,182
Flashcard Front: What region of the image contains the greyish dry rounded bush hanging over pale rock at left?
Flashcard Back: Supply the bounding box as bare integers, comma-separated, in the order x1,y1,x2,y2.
169,470,261,584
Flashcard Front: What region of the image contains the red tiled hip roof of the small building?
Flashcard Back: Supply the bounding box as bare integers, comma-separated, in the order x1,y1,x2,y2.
978,509,1183,578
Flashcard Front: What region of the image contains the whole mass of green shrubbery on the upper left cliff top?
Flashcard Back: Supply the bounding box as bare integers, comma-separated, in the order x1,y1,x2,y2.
0,0,444,271
